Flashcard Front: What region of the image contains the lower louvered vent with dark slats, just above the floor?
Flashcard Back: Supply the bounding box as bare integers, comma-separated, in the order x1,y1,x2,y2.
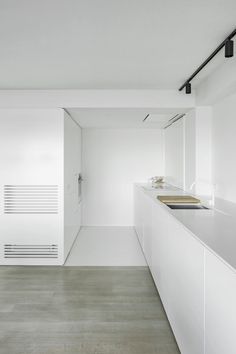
4,244,58,258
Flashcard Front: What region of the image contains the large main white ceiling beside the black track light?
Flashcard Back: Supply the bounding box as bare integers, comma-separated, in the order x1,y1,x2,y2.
0,0,236,89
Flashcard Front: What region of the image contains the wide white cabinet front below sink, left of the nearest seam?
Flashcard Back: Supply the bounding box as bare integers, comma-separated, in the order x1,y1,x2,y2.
152,203,204,354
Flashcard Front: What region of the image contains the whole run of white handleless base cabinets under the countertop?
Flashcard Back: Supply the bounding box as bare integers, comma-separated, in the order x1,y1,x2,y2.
134,186,236,354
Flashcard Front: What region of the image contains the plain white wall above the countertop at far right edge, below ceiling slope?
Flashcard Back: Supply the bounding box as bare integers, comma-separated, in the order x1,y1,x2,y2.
212,94,236,202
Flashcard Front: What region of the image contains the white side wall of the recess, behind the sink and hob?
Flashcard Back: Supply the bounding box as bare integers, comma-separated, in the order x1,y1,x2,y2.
165,106,212,196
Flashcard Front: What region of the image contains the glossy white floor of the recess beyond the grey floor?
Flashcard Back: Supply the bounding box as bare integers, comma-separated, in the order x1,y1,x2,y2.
65,227,146,266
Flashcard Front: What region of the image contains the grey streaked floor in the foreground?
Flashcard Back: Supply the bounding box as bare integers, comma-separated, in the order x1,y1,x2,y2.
0,266,179,354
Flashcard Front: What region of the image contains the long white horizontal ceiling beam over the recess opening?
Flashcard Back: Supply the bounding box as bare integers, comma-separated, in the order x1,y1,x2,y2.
0,90,195,108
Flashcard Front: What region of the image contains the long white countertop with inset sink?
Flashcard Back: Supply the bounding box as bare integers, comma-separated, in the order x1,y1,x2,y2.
137,184,236,271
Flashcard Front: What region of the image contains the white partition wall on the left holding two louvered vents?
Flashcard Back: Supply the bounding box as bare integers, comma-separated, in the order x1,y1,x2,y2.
0,109,80,265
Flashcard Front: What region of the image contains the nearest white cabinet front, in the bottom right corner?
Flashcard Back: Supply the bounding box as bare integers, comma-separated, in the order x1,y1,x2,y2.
205,250,236,354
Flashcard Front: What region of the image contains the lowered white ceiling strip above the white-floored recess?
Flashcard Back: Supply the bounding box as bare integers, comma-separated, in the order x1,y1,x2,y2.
67,108,190,129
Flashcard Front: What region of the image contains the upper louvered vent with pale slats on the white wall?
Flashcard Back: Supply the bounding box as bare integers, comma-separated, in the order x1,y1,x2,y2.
4,185,58,214
